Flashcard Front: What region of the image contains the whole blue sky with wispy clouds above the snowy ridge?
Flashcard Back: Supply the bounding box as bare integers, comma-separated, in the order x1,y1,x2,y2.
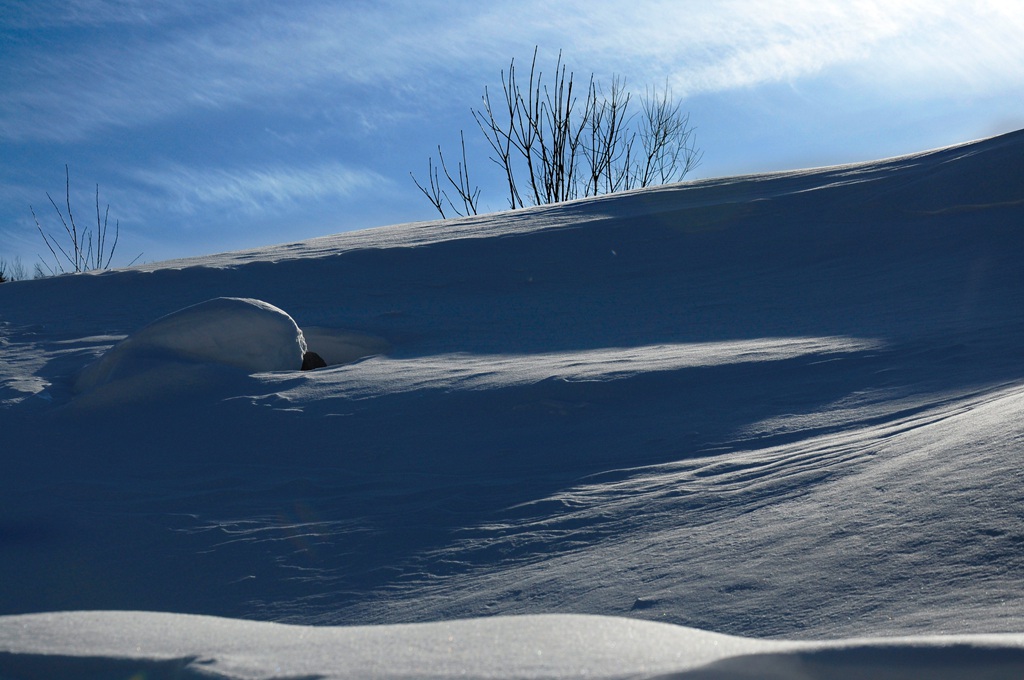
0,0,1024,268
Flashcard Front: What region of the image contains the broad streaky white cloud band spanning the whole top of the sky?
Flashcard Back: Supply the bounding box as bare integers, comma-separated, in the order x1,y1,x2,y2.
0,0,1024,140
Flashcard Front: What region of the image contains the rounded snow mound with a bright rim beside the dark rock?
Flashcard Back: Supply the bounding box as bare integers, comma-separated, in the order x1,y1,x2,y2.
75,297,306,392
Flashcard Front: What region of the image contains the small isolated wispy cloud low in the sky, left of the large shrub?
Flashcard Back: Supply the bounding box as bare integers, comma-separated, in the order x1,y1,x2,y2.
128,163,388,216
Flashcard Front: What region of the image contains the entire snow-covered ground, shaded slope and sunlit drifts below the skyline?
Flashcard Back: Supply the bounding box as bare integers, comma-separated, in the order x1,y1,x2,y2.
0,125,1024,680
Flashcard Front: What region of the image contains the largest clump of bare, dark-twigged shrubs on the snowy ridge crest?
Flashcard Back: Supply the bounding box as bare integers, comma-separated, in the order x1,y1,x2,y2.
410,48,702,217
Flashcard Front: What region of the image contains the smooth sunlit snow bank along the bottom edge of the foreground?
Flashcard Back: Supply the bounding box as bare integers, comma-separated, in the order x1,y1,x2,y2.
0,611,1024,679
